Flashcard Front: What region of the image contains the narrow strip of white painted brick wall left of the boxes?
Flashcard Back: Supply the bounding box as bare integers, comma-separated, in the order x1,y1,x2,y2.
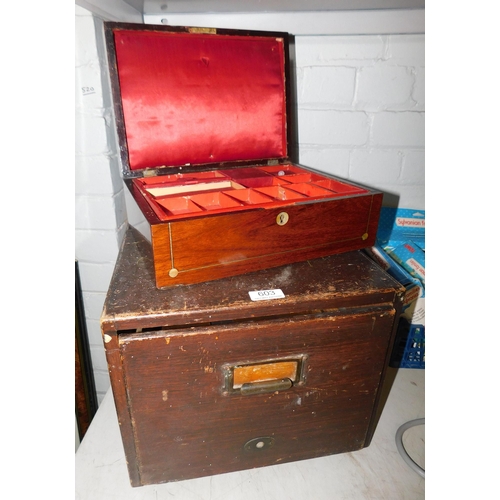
75,6,127,402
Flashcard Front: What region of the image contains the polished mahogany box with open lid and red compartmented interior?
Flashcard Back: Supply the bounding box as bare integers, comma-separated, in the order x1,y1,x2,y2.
105,22,383,288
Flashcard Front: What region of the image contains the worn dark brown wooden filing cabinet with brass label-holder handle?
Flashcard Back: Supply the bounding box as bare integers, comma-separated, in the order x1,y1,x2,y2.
101,228,404,486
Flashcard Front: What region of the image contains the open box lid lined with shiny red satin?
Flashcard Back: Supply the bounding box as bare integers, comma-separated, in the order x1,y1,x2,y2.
104,22,290,177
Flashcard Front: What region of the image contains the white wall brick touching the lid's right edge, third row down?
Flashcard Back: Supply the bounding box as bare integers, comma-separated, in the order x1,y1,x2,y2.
299,109,369,147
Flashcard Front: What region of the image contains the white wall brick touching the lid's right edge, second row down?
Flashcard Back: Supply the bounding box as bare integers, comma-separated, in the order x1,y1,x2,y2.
298,66,356,107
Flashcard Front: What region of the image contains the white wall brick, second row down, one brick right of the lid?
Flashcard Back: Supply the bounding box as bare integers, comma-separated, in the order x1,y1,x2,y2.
356,64,414,110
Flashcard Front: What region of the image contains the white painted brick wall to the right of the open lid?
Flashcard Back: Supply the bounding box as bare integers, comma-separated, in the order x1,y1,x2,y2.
296,35,425,210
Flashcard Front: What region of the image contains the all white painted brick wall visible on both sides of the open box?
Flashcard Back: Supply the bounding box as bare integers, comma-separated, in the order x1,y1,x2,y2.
75,7,425,400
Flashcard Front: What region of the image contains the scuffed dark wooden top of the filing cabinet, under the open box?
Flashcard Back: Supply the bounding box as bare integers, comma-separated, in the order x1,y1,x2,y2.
101,227,404,330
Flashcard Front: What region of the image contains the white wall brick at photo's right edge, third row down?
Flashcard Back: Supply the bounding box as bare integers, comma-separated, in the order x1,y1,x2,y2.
372,112,425,148
